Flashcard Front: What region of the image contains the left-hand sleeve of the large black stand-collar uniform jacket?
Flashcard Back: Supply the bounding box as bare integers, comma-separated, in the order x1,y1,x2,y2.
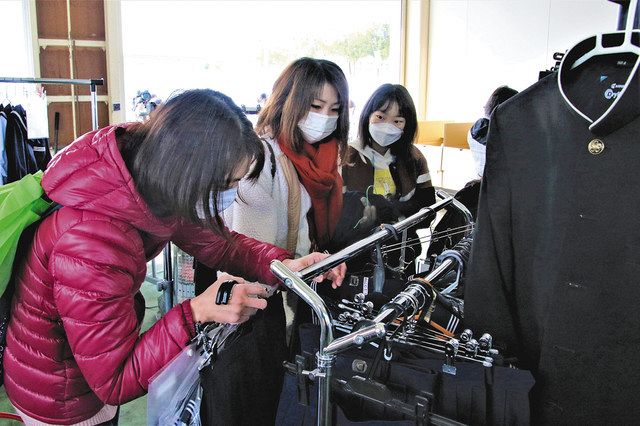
464,110,516,352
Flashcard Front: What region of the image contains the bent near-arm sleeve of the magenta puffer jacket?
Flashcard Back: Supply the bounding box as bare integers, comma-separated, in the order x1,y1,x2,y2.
49,220,194,405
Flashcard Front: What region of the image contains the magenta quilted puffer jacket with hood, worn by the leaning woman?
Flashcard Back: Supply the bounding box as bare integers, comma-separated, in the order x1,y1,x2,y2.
4,127,288,424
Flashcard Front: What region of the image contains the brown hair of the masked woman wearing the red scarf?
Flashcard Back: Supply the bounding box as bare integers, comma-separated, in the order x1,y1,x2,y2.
256,58,349,161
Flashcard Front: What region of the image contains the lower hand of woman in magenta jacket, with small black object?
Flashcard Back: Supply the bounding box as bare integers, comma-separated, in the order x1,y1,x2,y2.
191,274,269,324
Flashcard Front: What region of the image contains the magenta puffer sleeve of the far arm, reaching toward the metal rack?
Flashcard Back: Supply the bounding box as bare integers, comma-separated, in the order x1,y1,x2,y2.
172,222,292,285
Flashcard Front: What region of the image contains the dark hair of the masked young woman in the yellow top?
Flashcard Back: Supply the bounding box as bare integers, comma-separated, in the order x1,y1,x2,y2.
358,84,418,178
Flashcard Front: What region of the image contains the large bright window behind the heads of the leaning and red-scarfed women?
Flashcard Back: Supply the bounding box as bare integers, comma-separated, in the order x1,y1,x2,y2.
122,0,401,119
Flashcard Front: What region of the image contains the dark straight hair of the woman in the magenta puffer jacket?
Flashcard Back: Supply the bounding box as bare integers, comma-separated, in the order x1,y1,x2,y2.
122,89,264,235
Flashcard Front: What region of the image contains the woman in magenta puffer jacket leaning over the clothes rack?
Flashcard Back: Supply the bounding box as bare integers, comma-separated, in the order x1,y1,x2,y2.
4,90,344,425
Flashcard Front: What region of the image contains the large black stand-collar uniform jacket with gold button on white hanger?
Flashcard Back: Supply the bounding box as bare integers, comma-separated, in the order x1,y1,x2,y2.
465,30,640,424
